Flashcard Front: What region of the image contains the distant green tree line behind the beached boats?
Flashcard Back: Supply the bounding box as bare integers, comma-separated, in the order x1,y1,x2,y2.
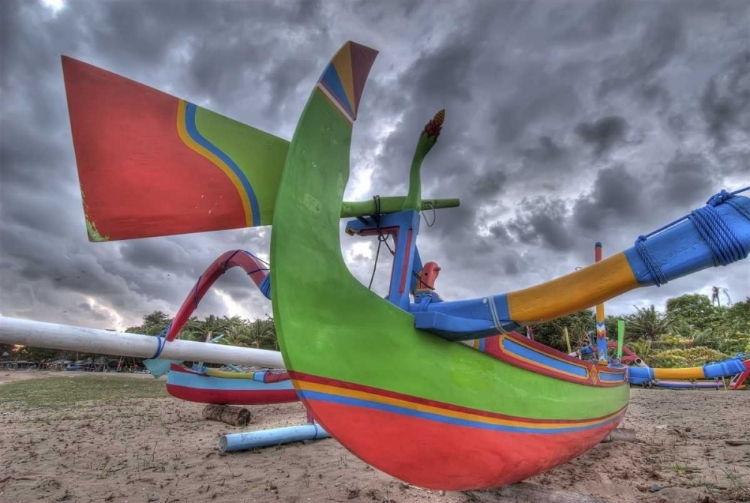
0,294,750,367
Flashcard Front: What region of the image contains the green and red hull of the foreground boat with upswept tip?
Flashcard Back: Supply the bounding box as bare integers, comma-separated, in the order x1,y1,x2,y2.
271,43,629,491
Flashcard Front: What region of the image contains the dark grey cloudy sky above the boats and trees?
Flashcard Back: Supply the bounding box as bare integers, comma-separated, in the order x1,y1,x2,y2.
0,0,750,334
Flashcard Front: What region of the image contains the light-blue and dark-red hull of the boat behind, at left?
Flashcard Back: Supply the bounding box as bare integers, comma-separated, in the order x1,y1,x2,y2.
167,365,299,405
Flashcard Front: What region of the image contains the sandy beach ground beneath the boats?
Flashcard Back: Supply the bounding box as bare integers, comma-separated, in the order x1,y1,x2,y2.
0,371,750,503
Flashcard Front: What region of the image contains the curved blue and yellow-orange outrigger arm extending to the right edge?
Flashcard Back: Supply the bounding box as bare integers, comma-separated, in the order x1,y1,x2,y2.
411,187,750,340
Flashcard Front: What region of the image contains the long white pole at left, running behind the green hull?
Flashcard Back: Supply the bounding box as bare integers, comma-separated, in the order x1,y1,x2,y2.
0,316,285,368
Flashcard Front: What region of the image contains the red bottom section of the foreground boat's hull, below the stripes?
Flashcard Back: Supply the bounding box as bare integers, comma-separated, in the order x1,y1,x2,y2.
305,399,624,491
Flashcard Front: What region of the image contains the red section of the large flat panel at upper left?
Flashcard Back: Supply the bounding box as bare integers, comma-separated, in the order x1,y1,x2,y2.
63,57,247,241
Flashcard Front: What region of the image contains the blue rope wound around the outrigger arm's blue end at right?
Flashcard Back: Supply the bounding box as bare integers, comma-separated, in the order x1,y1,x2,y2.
635,186,750,286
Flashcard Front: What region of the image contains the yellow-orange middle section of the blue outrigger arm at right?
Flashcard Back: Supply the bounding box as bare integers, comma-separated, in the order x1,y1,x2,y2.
508,253,638,325
